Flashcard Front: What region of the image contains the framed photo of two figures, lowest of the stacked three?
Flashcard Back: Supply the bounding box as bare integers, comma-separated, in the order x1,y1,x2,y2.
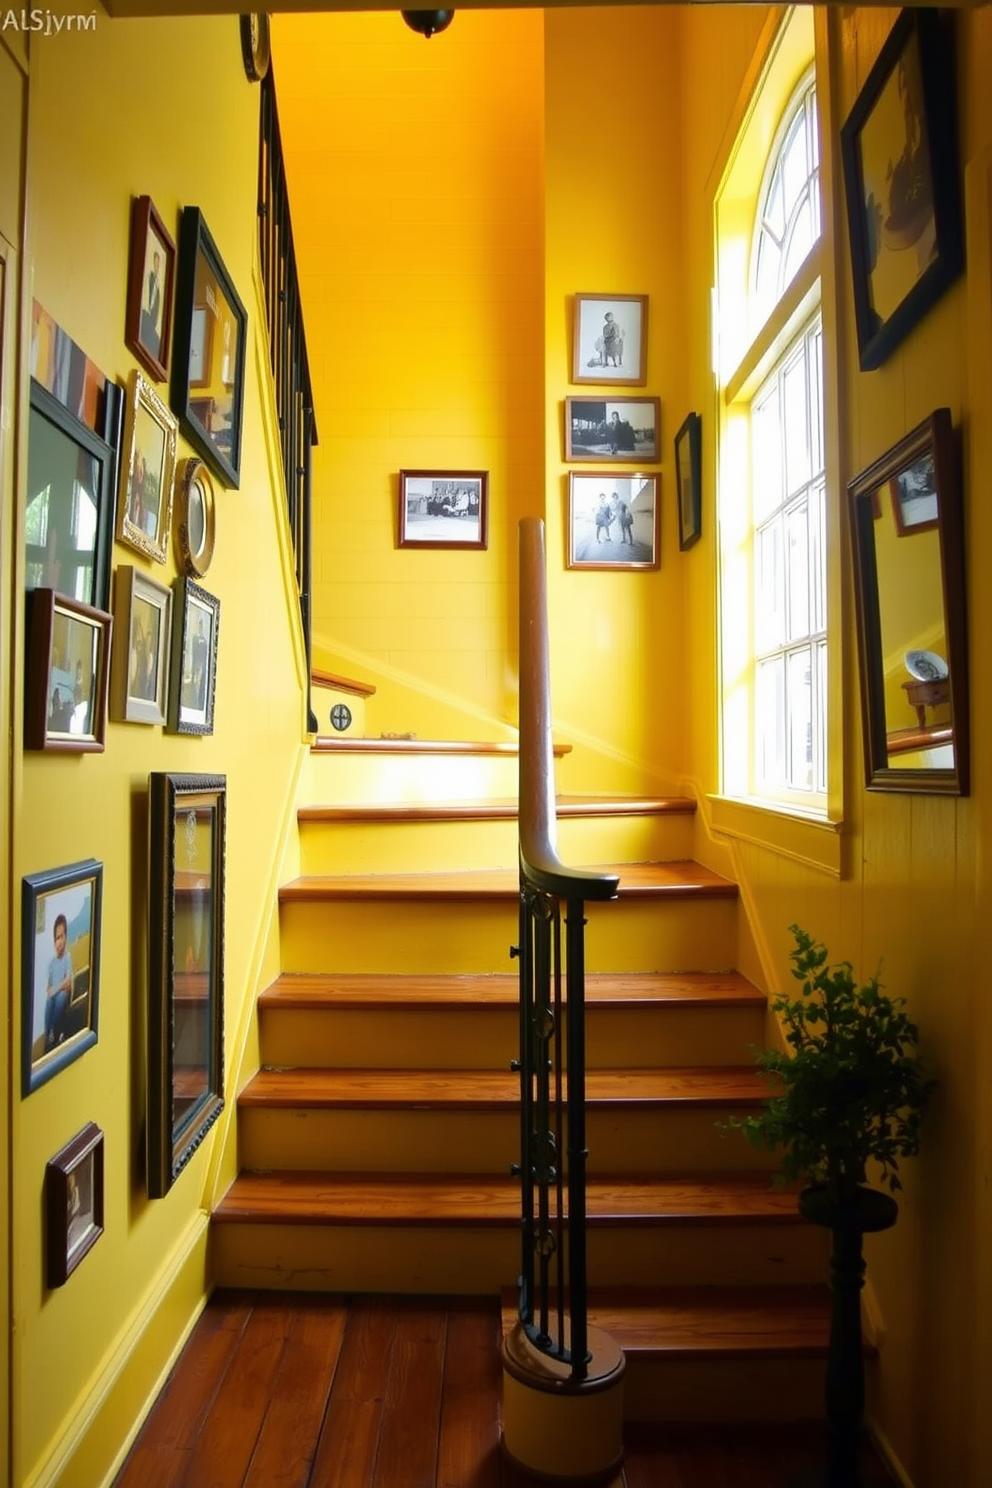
567,472,660,568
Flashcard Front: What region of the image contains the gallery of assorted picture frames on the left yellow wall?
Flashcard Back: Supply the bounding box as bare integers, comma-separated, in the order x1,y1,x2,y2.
19,196,247,1287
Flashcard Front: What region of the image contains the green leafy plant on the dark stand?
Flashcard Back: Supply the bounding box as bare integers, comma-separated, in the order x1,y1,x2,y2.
730,926,934,1204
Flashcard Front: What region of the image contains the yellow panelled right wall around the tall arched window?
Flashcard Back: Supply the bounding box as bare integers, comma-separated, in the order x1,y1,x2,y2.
681,6,992,1488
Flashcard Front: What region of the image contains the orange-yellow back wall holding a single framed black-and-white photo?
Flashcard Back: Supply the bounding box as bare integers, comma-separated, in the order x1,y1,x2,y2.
274,10,544,737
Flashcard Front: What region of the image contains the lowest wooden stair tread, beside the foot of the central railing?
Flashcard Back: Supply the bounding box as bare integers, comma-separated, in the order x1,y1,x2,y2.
503,1286,844,1360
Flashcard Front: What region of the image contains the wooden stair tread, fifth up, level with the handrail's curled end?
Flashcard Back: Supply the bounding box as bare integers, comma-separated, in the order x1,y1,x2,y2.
280,859,738,903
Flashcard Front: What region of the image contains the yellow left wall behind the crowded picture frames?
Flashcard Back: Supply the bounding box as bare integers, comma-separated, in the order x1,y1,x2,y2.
3,15,305,1488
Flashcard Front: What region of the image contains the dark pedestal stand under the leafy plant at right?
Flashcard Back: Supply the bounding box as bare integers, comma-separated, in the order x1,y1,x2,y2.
799,1184,898,1488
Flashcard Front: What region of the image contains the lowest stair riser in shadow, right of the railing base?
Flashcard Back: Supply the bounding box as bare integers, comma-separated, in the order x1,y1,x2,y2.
623,1353,825,1421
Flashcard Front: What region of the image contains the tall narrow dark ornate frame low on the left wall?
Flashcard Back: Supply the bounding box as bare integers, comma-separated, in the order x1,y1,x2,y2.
147,772,226,1198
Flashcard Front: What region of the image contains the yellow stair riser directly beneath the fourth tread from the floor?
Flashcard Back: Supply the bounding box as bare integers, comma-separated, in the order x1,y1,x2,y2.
260,1007,764,1070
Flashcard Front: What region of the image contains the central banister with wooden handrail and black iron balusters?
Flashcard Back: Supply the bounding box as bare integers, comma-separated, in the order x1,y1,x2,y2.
518,518,619,1381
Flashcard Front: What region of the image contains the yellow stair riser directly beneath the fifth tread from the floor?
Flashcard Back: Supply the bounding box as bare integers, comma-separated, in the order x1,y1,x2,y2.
280,897,736,975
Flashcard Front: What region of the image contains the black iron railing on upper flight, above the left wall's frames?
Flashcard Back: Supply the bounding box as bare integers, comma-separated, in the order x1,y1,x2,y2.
259,67,317,732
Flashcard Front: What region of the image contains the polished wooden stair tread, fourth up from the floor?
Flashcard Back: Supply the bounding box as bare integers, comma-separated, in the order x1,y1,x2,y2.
259,972,766,1012
